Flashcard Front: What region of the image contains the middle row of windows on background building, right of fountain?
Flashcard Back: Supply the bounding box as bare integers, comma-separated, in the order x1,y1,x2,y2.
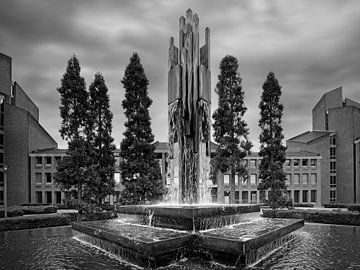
224,173,317,186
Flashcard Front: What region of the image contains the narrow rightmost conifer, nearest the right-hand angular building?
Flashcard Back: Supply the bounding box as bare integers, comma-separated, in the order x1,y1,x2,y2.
258,72,286,208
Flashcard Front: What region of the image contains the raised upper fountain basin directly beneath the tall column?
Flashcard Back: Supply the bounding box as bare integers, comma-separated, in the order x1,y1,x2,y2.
117,204,260,231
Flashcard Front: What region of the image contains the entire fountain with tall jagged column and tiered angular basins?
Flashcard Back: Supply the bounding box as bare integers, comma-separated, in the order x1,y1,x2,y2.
72,9,304,268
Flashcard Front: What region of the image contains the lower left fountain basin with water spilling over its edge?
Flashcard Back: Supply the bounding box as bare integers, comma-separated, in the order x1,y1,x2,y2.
72,220,193,268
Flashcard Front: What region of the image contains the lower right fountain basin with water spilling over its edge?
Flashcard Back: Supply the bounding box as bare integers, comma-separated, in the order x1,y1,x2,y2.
199,218,304,267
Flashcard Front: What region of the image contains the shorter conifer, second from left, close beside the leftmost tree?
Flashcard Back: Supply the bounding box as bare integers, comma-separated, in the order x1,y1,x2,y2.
87,73,115,203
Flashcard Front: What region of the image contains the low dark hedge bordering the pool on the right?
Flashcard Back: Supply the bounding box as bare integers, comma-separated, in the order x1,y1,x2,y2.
262,209,360,226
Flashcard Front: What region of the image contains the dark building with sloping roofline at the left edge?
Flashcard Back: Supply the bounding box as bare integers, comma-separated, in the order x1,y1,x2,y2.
0,53,57,205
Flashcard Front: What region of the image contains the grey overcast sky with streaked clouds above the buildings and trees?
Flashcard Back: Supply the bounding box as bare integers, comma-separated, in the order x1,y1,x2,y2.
0,0,360,151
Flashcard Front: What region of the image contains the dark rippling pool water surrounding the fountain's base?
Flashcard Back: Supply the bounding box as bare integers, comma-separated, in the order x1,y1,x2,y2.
0,224,360,270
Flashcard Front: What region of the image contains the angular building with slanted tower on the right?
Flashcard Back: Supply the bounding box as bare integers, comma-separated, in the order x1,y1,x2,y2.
287,87,360,204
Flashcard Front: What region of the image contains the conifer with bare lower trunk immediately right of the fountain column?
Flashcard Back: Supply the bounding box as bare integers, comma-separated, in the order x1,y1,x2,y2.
212,55,252,203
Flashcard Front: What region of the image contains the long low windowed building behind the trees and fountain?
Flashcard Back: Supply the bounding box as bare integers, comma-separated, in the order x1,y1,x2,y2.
30,142,321,206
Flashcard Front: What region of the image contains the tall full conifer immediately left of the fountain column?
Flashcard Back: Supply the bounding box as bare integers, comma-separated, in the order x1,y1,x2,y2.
120,53,164,204
